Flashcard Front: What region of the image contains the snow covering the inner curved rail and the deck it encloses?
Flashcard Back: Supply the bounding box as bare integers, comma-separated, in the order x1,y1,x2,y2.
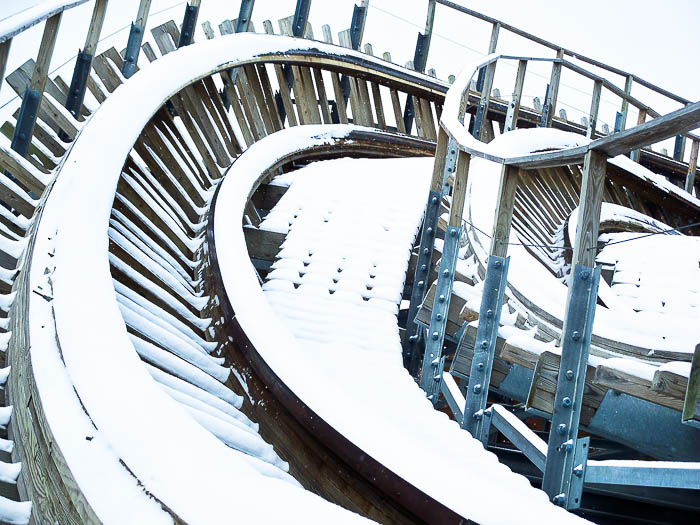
214,126,580,524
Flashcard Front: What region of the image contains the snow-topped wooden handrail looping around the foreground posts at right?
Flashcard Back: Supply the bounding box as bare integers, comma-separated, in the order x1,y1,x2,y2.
440,53,700,169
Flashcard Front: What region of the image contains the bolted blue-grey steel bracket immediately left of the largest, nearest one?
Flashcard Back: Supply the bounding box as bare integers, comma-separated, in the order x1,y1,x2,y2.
462,255,510,439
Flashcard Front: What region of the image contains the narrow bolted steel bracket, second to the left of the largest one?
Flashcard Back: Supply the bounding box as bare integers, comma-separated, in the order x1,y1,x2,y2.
420,226,462,405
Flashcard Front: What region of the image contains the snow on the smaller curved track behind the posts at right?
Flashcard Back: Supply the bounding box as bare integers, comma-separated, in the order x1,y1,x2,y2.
464,128,700,354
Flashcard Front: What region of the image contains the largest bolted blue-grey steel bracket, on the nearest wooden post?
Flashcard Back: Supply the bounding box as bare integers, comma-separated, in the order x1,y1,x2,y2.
542,264,600,507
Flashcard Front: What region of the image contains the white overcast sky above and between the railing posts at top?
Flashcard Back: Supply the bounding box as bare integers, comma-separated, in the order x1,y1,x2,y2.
0,0,700,149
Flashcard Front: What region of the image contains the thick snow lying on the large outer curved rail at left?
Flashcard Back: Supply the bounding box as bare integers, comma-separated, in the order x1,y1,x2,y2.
30,35,370,523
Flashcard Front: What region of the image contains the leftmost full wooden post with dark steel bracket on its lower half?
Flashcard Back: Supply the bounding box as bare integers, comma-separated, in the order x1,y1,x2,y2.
12,12,63,157
